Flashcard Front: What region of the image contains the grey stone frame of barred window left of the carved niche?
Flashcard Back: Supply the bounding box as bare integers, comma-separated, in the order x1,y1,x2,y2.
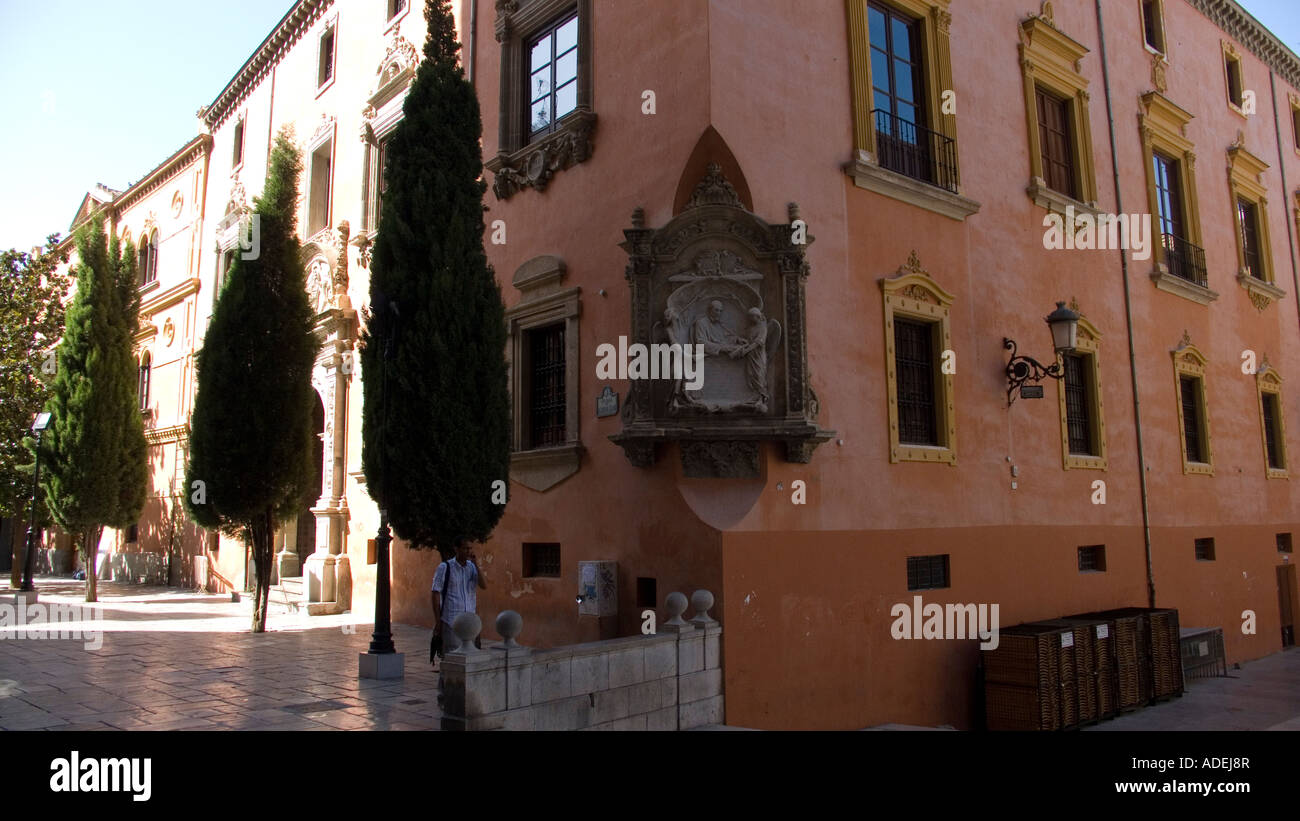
506,256,584,492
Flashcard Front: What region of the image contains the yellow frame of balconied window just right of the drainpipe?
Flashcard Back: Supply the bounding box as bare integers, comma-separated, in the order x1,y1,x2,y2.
1138,91,1218,305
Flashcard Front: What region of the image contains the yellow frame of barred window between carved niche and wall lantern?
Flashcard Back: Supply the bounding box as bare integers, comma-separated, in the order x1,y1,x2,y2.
880,251,957,465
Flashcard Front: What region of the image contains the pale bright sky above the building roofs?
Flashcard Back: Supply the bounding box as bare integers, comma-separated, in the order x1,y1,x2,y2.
0,0,1300,249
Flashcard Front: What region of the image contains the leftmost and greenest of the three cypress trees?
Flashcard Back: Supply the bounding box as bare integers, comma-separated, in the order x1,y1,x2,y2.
42,218,148,601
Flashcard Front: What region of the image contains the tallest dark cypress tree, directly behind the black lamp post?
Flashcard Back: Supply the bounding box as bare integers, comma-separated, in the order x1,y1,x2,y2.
361,0,510,553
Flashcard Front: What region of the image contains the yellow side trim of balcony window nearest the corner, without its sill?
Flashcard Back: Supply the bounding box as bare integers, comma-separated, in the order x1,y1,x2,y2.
845,0,961,168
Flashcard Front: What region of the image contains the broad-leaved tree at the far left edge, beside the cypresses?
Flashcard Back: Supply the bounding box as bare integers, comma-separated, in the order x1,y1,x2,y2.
0,234,72,584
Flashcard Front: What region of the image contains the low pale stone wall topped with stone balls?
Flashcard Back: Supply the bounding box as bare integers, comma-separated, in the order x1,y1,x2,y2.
442,590,725,730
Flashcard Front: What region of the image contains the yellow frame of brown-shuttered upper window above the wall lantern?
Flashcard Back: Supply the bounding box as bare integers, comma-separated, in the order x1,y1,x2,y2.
1019,4,1097,210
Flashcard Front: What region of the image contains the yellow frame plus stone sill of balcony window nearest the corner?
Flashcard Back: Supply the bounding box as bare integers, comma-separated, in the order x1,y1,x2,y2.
845,0,980,220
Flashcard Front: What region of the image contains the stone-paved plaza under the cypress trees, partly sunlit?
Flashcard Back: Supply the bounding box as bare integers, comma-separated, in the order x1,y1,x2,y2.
0,577,442,730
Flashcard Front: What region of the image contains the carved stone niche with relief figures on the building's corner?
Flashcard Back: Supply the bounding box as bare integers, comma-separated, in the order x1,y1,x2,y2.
610,164,835,478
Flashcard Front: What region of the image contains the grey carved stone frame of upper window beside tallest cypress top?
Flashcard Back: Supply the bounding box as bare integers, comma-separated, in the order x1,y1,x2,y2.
484,0,595,200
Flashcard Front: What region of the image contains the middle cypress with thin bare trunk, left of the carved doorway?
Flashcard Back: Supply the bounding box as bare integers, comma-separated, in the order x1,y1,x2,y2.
185,131,319,633
